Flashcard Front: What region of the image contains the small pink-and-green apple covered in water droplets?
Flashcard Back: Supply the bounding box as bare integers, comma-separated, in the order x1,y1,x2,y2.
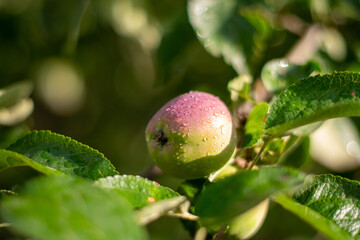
145,91,236,179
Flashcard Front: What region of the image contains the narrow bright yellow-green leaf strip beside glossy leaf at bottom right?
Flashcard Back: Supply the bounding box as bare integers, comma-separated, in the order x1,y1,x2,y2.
274,195,353,240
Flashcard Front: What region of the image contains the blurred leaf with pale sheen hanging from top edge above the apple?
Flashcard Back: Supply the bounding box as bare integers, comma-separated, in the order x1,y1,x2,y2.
188,0,271,74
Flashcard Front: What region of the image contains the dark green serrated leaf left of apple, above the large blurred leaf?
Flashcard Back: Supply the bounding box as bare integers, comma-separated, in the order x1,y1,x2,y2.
8,131,117,179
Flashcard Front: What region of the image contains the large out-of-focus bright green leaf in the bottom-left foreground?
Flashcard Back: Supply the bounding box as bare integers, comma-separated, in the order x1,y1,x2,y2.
0,176,146,240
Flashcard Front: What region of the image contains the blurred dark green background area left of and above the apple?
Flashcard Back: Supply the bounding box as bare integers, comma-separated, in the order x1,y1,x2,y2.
0,0,235,174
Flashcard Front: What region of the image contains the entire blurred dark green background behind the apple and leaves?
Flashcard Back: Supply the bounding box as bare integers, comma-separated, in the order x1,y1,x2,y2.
0,0,360,239
